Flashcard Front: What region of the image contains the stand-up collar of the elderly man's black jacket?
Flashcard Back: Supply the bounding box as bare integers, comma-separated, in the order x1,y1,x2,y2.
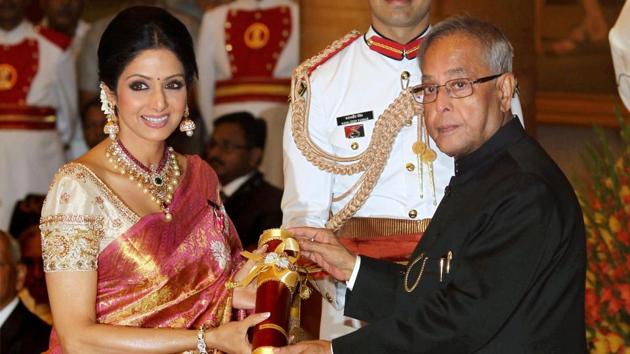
455,116,526,180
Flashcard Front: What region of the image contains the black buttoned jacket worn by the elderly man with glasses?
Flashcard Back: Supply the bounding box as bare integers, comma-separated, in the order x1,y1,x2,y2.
333,119,586,354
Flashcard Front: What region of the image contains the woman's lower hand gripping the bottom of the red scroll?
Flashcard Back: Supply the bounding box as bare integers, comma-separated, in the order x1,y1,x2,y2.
206,312,270,354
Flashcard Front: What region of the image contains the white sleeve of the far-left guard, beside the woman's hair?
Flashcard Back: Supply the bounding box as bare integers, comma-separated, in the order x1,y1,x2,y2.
55,51,80,144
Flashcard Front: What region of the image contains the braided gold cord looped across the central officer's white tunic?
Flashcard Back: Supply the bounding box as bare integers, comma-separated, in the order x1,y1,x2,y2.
291,31,421,231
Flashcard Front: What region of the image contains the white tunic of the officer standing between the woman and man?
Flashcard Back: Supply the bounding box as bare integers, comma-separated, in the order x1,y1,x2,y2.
282,28,521,339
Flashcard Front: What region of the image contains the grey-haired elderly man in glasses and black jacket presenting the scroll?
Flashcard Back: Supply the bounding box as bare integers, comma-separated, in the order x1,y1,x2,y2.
275,18,586,354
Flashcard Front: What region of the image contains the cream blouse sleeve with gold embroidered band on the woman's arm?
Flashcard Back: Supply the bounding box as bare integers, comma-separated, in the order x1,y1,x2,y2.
40,163,137,272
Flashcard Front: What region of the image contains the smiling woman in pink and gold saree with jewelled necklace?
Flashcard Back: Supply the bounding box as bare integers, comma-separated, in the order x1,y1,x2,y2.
40,7,268,353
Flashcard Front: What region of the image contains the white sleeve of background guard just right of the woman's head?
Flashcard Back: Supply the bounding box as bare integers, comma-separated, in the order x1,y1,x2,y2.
197,11,217,134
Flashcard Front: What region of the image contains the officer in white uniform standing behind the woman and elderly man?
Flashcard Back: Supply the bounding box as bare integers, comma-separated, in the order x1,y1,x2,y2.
282,0,522,339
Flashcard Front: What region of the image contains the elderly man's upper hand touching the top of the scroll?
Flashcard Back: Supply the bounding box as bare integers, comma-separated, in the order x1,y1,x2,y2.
287,227,357,281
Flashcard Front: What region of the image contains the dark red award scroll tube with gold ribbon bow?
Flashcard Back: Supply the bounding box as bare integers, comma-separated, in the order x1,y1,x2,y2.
241,229,310,354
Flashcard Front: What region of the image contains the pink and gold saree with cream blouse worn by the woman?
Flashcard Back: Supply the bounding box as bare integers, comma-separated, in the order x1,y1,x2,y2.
40,156,241,353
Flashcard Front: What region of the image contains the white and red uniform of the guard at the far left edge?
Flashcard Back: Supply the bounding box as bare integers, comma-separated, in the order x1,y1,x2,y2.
0,21,78,230
